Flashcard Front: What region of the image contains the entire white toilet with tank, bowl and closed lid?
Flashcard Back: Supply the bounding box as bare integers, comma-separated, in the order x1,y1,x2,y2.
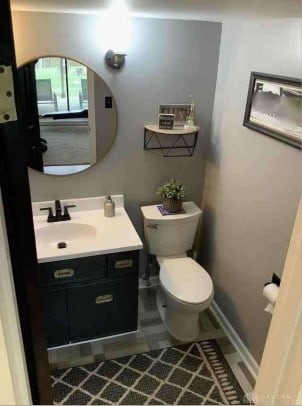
141,202,214,341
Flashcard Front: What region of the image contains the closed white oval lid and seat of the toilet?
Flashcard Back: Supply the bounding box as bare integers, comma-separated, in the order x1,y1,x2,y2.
159,257,213,305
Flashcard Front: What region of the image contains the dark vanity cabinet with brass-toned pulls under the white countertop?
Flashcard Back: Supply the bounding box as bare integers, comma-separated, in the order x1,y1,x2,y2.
39,251,138,347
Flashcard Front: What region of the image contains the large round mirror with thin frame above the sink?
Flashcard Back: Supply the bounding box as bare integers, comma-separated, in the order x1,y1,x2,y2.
18,56,117,175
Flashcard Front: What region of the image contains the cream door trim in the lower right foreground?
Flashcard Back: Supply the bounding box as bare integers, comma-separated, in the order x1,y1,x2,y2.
253,198,302,406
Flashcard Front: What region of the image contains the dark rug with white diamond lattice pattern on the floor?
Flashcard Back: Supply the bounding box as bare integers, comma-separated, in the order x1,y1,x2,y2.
52,340,249,405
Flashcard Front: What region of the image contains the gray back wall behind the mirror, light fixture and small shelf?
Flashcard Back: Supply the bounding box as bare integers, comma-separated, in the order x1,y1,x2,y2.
13,12,221,251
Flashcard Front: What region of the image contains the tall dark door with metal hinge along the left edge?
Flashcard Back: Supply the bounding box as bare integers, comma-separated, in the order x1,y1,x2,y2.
0,0,53,404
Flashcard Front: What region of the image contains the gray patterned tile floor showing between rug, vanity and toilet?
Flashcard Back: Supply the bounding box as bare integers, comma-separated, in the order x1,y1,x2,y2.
48,286,255,393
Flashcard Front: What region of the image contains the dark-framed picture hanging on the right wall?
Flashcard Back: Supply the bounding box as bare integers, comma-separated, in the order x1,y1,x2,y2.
243,72,302,149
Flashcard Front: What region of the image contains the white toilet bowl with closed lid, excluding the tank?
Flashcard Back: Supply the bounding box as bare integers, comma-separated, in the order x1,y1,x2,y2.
156,257,214,342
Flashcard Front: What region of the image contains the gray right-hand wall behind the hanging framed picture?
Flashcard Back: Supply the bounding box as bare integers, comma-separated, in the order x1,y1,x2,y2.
201,20,302,362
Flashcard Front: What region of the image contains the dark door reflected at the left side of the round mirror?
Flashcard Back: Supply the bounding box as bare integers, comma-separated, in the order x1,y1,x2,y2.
18,61,43,172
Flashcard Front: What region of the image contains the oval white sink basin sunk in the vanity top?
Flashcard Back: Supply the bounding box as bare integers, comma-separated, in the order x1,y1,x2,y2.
36,221,96,244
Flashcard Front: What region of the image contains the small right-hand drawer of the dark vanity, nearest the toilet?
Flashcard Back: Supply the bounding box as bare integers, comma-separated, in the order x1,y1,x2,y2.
108,251,139,277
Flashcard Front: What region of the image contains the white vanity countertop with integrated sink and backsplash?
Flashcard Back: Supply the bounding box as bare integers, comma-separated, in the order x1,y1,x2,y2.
32,195,143,263
